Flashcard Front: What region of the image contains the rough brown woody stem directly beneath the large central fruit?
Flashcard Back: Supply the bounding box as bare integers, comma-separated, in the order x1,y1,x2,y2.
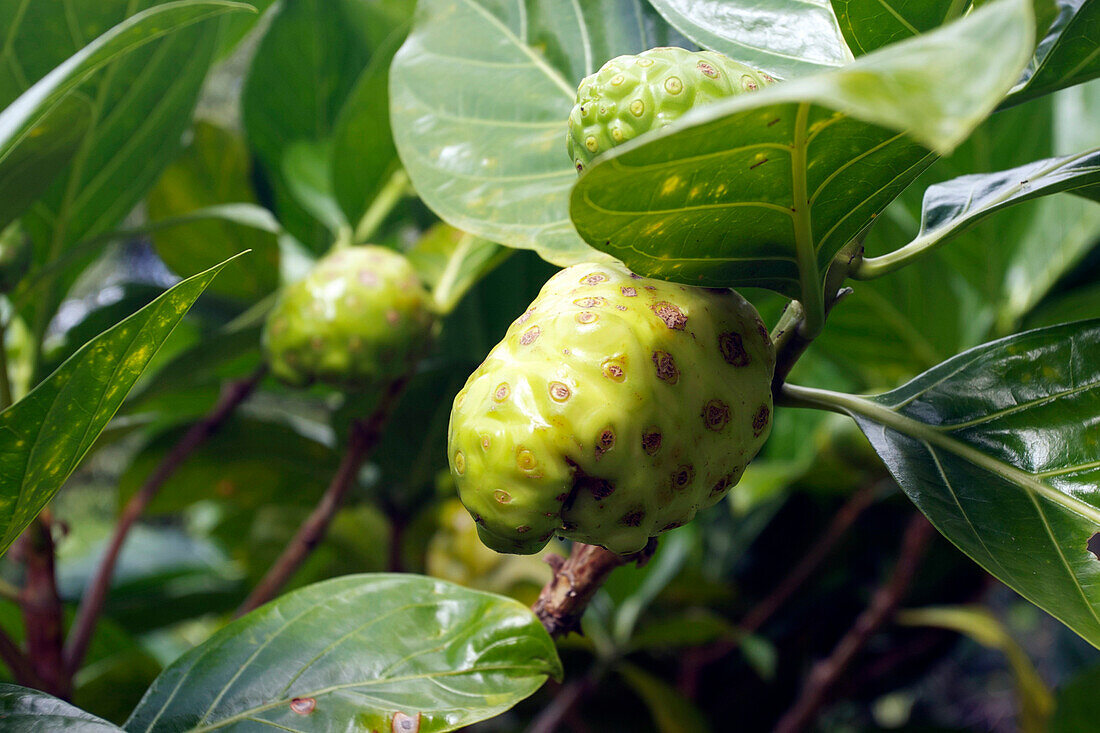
534,537,657,637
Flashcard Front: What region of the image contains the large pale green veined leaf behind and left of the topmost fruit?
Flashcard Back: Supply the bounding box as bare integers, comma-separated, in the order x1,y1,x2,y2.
391,0,670,265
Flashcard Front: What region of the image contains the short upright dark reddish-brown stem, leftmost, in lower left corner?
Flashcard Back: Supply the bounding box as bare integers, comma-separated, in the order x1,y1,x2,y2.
19,511,73,700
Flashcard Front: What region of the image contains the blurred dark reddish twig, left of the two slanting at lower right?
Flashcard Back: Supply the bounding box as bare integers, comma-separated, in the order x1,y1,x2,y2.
679,484,876,699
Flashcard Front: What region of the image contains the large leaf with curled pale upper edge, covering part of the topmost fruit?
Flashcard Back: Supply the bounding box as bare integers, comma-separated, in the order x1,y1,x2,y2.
571,0,1033,302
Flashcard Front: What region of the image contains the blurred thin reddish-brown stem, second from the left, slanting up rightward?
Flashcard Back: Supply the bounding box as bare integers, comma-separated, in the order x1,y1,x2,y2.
65,367,267,675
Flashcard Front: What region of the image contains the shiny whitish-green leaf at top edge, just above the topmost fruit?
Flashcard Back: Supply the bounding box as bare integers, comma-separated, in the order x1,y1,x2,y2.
651,0,851,79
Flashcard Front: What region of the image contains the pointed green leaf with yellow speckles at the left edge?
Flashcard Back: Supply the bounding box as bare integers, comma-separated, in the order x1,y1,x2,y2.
0,254,236,551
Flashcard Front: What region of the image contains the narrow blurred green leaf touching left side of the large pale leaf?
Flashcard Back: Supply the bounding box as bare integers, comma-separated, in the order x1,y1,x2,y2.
332,25,406,227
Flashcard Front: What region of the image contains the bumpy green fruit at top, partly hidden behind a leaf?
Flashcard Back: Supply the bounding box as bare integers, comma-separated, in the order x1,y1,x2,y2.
569,47,774,173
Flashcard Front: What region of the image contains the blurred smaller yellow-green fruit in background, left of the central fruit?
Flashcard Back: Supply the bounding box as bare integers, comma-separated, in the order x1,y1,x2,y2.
264,247,436,389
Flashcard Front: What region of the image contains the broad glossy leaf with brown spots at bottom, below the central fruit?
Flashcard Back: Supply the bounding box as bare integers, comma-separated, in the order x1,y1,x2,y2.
125,575,561,733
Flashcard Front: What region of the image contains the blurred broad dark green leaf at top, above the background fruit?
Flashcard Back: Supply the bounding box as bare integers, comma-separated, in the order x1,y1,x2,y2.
241,0,370,251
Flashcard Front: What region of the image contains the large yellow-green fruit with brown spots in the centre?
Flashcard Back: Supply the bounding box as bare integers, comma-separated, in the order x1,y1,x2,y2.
449,263,776,554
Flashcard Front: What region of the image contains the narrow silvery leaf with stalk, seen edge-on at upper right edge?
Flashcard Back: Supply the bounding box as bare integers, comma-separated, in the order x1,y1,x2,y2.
857,149,1100,277
